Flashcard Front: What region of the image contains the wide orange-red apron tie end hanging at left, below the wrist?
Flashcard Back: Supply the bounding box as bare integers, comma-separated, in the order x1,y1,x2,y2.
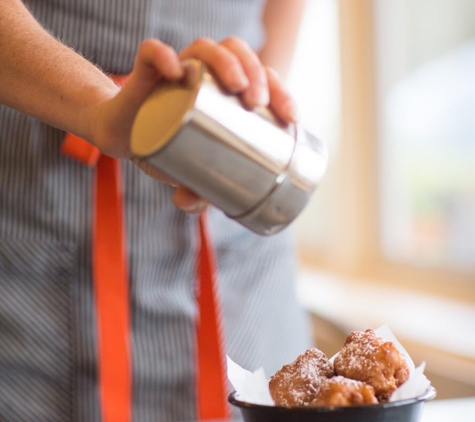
93,155,132,422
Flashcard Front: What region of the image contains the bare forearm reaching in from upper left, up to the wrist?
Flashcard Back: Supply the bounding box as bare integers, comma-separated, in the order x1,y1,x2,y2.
0,0,118,139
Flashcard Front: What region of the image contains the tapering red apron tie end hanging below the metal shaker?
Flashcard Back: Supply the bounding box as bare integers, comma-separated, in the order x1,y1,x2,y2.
197,214,229,421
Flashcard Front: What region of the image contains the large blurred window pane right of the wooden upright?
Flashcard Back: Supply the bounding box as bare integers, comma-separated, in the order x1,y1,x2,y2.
375,0,475,272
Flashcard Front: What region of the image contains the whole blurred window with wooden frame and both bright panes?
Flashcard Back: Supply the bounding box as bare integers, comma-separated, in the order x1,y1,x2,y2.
289,0,475,301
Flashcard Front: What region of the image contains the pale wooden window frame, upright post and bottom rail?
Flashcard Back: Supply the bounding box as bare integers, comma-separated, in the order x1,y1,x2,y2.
301,0,475,303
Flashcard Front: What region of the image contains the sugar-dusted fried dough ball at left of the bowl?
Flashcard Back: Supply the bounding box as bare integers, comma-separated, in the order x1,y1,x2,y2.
269,348,333,407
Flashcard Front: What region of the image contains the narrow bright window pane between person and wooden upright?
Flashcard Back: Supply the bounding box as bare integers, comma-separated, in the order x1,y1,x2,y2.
288,0,341,250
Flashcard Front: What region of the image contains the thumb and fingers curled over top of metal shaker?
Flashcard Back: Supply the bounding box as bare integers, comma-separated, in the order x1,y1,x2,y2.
121,37,297,123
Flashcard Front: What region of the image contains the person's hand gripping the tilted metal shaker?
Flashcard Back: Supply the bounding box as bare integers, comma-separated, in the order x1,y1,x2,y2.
87,37,296,213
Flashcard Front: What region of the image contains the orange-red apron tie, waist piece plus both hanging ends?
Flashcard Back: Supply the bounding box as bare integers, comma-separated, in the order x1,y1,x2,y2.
61,71,229,422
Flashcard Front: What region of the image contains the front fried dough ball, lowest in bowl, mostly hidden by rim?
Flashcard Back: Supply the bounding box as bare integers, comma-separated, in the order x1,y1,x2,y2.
310,375,378,406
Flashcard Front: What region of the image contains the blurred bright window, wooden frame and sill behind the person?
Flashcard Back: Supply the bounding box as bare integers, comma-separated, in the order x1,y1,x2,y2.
288,0,475,399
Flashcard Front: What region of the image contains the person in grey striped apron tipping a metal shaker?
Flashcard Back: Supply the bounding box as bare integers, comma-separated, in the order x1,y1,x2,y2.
0,0,312,422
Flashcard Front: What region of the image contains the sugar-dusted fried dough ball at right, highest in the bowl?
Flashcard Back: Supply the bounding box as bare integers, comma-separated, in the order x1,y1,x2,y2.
334,330,409,401
